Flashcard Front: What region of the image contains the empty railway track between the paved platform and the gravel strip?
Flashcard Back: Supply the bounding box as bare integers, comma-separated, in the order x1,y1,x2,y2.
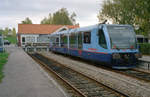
29,53,128,97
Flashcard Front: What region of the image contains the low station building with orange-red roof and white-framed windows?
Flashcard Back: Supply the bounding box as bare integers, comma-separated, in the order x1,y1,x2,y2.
17,24,79,47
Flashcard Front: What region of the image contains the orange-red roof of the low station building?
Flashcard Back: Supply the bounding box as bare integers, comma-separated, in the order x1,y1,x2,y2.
18,24,79,34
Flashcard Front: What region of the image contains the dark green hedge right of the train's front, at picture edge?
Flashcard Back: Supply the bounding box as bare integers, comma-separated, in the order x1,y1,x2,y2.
139,43,150,55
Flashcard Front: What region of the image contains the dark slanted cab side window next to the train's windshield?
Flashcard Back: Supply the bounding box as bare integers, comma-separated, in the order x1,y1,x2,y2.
98,29,107,49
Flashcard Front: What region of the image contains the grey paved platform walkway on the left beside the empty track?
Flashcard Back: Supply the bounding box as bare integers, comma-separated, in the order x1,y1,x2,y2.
0,45,67,97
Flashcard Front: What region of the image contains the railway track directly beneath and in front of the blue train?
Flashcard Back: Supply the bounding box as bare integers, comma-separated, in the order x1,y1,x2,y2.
58,52,150,82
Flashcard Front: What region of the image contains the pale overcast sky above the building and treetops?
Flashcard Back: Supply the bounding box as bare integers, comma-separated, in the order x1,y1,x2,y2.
0,0,103,28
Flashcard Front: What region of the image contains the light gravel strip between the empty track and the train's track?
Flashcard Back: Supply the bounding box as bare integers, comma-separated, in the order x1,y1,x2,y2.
41,52,150,97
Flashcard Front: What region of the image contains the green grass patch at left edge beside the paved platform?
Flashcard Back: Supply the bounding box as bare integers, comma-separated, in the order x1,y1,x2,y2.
0,52,8,82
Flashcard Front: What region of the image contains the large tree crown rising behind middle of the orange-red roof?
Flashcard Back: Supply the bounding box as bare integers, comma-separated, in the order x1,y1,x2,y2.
41,8,76,25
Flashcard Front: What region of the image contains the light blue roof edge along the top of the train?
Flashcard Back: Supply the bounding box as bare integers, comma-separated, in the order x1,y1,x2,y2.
51,24,131,35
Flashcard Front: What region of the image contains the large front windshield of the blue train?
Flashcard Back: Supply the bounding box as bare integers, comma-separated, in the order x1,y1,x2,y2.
107,25,136,49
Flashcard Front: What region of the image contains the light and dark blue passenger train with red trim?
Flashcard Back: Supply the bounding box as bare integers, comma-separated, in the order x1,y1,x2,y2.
49,24,141,69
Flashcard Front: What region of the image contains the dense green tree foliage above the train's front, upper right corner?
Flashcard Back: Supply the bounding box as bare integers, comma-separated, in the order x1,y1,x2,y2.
98,0,150,35
